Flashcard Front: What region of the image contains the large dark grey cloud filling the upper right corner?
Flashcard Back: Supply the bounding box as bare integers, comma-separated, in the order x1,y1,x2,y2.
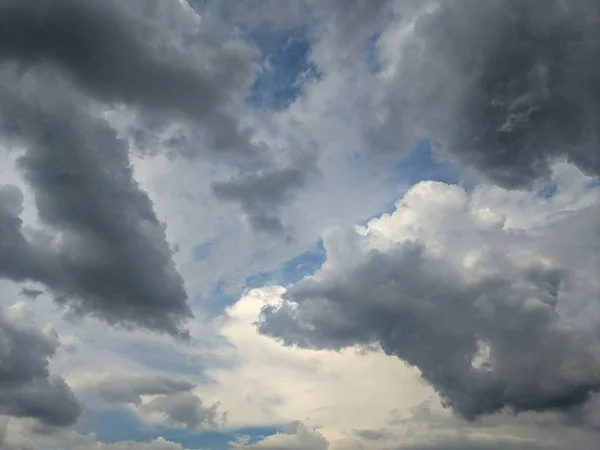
365,0,600,188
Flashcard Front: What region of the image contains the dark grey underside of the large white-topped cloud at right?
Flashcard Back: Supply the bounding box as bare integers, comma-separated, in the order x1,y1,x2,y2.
259,188,600,419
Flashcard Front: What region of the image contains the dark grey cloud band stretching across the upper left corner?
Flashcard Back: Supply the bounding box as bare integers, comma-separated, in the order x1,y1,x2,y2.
0,0,252,155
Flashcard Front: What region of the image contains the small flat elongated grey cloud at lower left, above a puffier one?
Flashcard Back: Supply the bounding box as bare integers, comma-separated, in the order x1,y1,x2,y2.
96,375,194,404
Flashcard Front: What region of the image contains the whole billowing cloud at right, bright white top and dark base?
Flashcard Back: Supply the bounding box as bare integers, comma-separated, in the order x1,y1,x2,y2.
259,165,600,419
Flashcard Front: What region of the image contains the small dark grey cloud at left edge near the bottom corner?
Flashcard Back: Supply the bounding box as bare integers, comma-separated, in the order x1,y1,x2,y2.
0,304,81,426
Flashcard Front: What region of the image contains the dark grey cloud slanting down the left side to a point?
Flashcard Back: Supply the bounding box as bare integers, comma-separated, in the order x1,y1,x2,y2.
0,76,191,336
